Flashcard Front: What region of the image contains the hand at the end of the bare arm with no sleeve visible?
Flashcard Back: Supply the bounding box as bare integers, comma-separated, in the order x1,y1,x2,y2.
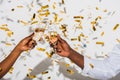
16,34,36,52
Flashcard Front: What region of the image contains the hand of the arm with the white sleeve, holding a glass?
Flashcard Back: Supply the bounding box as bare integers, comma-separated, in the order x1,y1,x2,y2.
50,35,72,57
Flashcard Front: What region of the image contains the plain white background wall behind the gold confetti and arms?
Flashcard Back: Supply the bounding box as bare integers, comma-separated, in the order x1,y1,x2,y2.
0,0,120,80
